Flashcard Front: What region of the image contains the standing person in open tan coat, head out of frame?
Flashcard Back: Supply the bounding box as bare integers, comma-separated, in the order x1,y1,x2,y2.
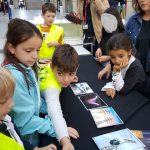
78,0,109,56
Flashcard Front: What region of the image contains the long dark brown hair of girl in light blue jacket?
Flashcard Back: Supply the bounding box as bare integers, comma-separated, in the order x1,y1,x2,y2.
3,18,42,88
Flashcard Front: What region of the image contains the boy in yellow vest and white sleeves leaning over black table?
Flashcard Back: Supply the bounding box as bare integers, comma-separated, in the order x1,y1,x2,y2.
40,44,79,150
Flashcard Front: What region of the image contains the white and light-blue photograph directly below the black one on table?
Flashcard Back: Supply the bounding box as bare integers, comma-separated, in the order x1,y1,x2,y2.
90,107,123,128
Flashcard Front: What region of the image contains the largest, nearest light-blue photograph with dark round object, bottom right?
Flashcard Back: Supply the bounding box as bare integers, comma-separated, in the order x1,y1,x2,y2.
93,128,145,150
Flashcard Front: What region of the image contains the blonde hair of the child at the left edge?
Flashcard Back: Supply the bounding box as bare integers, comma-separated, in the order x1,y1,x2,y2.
0,67,15,100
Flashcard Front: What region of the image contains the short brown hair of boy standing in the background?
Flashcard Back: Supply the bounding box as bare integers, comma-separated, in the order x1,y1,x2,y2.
42,3,56,15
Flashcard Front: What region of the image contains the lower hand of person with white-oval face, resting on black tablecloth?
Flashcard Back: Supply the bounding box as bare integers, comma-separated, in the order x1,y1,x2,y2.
98,64,111,80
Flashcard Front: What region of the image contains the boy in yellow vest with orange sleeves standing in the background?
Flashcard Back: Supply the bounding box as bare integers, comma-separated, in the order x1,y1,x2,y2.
37,3,64,61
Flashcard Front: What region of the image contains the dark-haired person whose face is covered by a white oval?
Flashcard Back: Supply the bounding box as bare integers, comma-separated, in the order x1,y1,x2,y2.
95,7,124,79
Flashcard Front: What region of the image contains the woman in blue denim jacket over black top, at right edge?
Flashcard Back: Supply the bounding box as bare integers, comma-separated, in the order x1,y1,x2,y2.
125,0,150,77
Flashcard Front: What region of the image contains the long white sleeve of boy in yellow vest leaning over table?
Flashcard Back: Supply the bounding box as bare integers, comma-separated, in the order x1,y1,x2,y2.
43,88,69,141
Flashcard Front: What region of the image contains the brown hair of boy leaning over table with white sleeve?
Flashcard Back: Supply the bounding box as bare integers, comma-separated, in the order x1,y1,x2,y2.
52,44,79,72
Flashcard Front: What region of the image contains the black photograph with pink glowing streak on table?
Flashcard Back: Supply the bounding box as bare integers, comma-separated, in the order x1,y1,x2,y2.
78,93,108,110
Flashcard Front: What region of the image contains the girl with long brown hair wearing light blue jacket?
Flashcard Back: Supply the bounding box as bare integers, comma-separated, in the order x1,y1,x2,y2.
3,19,58,145
